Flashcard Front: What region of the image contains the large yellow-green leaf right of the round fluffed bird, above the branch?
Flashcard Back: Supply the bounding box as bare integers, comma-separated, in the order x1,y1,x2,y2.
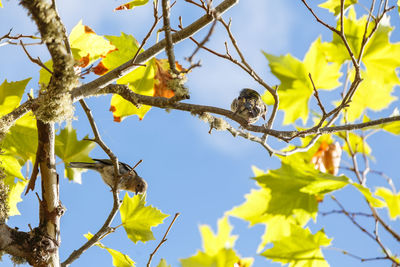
263,38,341,124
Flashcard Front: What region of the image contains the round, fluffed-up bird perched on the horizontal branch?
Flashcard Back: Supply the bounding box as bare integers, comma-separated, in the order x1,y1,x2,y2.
231,88,267,124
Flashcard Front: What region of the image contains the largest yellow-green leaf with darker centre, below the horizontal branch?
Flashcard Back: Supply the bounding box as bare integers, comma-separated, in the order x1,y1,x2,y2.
227,140,349,251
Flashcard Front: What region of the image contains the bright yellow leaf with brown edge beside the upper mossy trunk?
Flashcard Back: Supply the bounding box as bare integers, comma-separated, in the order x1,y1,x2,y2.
69,21,115,66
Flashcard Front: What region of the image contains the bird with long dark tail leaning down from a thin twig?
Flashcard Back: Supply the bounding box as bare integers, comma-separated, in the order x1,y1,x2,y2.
69,159,147,194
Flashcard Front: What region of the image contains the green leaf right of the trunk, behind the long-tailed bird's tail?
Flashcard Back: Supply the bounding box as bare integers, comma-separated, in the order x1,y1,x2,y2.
55,124,96,183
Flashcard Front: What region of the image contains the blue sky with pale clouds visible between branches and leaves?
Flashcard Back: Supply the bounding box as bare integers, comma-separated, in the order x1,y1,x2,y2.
0,0,400,267
